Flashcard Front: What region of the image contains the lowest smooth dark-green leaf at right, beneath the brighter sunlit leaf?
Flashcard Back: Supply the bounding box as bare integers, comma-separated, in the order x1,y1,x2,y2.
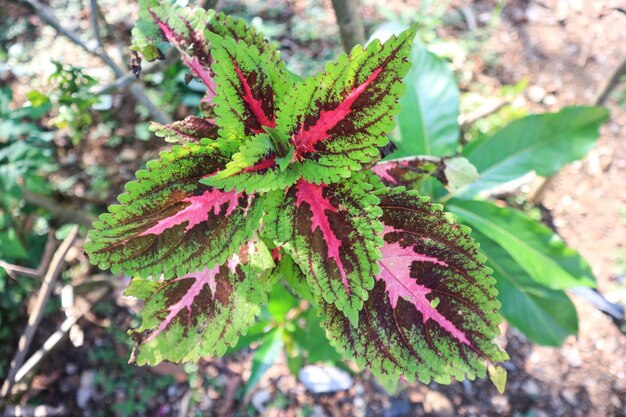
472,230,578,346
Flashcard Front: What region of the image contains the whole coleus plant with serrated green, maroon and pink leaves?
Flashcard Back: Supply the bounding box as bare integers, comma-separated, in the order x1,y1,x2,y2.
85,1,507,383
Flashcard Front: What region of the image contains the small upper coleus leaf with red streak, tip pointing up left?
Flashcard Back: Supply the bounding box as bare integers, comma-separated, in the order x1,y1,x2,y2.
207,33,289,141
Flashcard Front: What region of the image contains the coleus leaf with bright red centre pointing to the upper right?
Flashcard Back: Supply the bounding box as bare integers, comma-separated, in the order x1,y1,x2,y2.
277,28,415,183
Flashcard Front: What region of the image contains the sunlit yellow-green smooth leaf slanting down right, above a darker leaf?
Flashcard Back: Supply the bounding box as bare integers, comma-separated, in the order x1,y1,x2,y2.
447,200,596,290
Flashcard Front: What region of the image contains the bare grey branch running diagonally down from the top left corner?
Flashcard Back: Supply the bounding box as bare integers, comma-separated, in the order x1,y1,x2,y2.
21,0,172,124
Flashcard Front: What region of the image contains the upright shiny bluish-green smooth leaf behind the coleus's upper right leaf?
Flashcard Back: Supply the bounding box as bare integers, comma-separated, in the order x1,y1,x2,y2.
389,43,460,159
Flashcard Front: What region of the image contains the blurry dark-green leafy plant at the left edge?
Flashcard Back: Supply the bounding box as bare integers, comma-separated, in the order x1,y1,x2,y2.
0,87,55,371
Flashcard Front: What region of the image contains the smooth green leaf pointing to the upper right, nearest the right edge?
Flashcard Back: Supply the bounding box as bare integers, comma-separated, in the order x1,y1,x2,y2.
457,106,608,198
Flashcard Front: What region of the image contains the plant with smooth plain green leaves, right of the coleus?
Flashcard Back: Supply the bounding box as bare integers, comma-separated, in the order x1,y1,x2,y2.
375,31,608,346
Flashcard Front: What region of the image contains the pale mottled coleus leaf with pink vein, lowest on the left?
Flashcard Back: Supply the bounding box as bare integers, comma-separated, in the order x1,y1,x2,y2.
125,237,274,365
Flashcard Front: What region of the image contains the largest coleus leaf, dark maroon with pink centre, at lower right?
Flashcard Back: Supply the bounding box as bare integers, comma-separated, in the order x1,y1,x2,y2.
322,189,507,383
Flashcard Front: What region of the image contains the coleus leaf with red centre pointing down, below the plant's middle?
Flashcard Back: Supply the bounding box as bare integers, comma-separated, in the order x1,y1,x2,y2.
264,174,382,326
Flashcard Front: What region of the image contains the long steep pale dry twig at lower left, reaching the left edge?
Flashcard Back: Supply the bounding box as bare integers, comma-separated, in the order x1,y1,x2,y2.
0,226,78,400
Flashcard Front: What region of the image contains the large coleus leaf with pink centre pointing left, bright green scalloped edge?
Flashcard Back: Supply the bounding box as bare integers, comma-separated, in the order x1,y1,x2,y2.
85,140,263,278
